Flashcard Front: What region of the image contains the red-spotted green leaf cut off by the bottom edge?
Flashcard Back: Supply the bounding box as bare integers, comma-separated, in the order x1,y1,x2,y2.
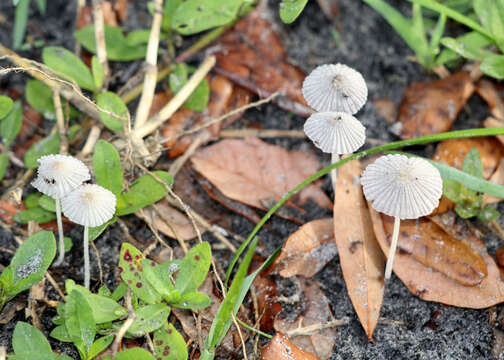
153,323,188,360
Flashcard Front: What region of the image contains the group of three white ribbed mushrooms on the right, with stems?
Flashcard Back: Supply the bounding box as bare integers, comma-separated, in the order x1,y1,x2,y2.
302,64,443,280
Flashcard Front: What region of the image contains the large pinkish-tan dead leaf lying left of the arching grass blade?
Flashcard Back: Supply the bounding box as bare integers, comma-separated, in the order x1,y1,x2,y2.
191,138,330,219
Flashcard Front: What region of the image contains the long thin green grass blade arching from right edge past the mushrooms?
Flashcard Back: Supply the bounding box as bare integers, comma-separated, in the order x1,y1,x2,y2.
225,128,504,284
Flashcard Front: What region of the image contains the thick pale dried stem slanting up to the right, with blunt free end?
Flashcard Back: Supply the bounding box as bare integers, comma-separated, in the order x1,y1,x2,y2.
132,56,215,138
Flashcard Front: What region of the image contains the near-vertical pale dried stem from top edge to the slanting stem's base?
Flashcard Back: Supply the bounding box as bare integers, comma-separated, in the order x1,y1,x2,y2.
135,0,163,129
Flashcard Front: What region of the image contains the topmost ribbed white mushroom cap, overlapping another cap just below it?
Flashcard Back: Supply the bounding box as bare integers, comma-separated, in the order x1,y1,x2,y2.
302,64,368,114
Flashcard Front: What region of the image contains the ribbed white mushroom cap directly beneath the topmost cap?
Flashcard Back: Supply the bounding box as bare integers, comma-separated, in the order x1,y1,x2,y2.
304,112,366,154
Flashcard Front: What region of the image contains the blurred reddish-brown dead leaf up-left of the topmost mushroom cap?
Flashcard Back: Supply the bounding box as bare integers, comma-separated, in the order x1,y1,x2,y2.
215,9,311,116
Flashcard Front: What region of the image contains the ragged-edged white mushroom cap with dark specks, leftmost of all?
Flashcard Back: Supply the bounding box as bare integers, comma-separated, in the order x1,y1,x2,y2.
32,155,91,199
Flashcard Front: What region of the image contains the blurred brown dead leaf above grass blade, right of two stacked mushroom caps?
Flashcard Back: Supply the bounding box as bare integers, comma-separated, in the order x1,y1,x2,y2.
398,72,474,139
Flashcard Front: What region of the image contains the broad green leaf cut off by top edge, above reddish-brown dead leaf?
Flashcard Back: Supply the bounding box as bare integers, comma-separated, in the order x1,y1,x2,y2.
172,0,243,35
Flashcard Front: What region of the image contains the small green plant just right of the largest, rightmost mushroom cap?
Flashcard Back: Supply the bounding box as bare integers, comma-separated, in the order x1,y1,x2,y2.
443,148,500,221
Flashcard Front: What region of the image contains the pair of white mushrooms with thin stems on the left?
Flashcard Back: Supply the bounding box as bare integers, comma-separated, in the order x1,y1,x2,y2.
32,155,116,288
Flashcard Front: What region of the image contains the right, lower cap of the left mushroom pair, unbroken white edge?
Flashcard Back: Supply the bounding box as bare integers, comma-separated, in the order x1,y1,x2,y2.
61,184,116,226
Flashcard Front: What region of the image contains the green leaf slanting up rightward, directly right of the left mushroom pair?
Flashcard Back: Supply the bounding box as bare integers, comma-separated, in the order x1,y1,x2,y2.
117,171,173,216
